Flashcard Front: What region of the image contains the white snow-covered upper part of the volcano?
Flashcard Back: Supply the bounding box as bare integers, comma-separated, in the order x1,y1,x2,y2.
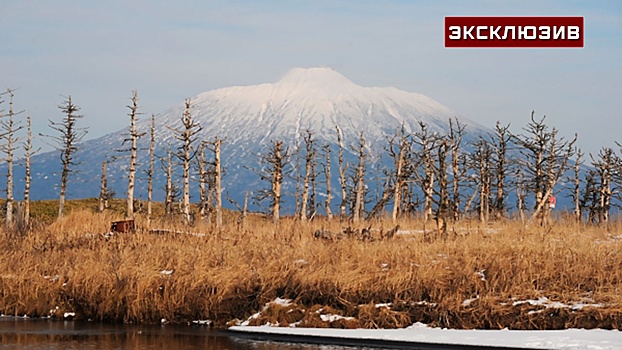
150,67,484,148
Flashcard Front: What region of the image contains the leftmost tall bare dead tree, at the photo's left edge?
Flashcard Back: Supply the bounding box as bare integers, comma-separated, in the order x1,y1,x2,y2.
0,89,23,227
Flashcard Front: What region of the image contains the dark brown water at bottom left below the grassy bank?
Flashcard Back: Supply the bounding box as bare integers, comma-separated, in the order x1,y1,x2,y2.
0,317,390,350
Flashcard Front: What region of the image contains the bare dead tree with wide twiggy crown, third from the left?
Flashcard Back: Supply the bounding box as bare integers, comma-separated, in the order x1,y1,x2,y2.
48,96,87,219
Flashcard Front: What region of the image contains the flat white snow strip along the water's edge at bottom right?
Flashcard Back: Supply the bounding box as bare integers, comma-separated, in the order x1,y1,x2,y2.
229,323,622,350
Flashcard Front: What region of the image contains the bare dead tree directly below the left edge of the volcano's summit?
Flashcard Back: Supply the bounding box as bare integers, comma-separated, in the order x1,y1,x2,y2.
255,140,289,224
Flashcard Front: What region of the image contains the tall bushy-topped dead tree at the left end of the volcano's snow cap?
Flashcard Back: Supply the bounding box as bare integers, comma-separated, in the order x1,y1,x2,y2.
169,99,202,223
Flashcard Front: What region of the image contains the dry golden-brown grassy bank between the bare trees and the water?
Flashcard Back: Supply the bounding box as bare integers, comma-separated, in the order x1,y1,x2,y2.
0,201,622,329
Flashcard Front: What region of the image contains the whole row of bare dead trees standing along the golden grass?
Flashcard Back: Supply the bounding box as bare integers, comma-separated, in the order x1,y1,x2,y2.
0,89,622,233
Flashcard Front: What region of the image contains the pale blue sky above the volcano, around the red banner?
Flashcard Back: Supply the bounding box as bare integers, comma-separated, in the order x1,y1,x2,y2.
0,0,622,152
